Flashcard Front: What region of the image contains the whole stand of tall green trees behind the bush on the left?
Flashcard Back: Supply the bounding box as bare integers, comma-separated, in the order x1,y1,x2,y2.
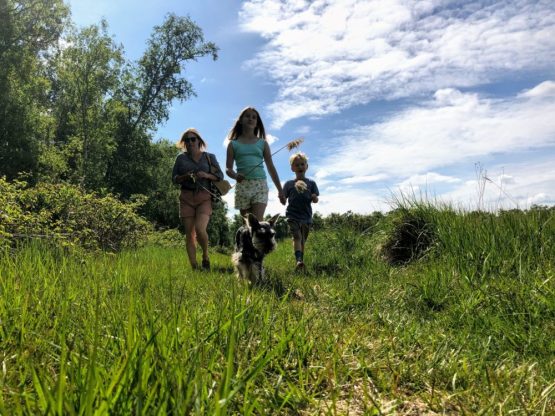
0,0,218,226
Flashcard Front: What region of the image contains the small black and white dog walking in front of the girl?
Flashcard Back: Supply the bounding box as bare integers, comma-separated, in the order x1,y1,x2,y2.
231,213,279,284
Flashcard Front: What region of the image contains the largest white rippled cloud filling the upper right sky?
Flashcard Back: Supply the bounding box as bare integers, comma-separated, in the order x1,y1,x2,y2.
240,0,555,128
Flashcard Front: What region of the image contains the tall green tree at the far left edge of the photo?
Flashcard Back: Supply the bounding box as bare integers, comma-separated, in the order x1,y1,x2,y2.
0,0,69,178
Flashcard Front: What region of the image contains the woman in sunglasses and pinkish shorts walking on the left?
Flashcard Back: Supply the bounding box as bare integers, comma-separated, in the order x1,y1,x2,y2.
172,128,223,270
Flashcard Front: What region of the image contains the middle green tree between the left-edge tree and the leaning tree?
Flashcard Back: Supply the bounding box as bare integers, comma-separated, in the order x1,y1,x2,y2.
47,20,123,189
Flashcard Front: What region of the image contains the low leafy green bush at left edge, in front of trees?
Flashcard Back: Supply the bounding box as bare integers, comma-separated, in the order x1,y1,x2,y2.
0,178,150,251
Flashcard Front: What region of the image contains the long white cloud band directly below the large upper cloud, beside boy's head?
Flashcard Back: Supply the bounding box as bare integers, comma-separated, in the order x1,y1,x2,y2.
314,84,555,181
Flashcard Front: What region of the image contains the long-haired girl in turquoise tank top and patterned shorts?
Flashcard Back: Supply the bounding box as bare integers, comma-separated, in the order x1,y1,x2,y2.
226,107,283,221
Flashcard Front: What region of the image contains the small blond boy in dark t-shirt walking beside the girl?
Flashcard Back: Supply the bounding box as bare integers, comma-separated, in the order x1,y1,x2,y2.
280,152,320,270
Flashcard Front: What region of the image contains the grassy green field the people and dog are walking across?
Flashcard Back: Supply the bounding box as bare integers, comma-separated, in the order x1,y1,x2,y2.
0,205,555,415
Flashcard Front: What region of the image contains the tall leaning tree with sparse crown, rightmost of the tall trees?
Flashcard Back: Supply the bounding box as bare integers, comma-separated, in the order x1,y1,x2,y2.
108,14,218,197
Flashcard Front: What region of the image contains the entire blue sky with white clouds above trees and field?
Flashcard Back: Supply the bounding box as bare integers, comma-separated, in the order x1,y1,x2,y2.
69,0,555,215
